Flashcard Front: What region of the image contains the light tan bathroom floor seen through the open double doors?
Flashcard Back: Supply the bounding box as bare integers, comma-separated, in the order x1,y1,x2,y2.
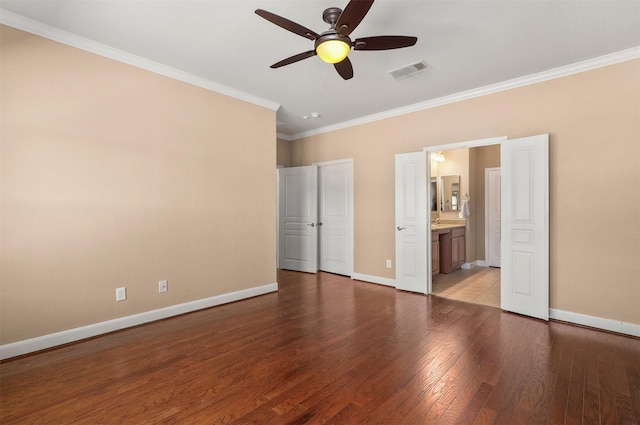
431,267,500,308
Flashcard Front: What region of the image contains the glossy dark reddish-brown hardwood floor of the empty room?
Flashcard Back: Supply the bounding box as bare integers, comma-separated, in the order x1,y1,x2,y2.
0,271,640,425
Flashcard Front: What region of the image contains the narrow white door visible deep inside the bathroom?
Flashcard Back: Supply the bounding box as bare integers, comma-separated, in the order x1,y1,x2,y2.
484,168,500,267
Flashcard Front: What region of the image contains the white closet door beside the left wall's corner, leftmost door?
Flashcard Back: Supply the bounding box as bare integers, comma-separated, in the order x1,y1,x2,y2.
278,165,318,273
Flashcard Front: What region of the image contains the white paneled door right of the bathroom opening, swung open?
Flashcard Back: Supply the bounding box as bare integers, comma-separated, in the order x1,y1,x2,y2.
500,134,549,320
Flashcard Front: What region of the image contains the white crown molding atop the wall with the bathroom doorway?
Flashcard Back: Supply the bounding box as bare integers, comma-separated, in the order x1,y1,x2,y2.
290,46,640,140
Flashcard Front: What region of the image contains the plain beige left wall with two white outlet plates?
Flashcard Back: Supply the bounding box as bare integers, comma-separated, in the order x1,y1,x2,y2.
0,27,276,344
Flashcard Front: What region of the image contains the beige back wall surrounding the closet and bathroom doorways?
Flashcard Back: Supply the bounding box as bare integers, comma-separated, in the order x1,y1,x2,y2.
291,60,640,324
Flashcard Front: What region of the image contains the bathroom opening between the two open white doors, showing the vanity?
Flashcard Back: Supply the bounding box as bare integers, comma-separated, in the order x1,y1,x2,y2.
430,144,501,308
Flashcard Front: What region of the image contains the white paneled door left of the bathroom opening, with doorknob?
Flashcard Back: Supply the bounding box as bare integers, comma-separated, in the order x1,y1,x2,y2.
396,151,431,294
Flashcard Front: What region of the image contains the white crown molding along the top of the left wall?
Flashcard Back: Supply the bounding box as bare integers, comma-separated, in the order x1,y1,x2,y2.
0,9,280,111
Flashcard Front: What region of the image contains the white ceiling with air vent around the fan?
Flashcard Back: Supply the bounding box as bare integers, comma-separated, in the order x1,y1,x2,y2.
0,0,640,138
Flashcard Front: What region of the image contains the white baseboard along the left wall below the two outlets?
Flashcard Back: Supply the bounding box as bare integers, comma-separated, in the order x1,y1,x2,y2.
0,282,278,360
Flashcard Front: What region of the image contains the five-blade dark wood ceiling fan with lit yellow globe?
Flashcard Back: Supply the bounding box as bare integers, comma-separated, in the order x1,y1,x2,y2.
256,0,418,80
